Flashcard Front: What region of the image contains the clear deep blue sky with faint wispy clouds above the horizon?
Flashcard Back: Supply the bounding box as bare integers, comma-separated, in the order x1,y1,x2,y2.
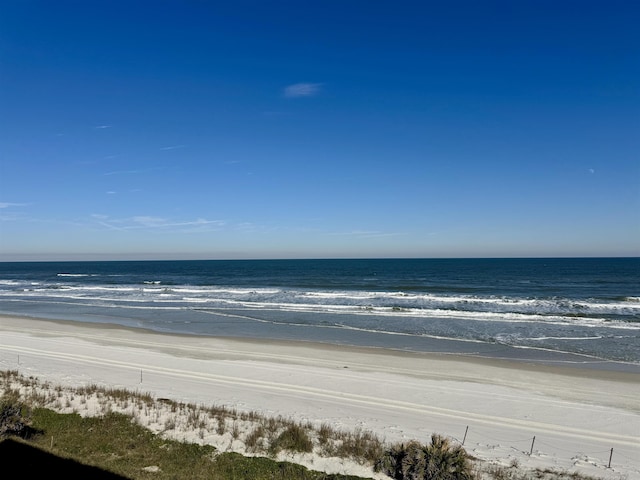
0,0,640,260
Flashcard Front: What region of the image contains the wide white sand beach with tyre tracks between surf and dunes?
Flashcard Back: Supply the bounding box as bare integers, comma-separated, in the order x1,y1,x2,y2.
0,317,640,480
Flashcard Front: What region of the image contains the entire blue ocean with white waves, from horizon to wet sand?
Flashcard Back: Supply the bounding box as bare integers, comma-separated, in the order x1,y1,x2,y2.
0,258,640,368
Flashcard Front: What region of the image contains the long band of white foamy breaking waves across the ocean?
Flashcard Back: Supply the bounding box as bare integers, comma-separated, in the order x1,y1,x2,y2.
0,282,640,329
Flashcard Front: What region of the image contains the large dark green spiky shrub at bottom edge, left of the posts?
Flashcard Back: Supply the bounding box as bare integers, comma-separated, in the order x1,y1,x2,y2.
375,434,473,480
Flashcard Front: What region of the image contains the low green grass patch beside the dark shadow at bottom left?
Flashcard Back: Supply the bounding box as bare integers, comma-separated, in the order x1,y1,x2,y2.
5,408,368,480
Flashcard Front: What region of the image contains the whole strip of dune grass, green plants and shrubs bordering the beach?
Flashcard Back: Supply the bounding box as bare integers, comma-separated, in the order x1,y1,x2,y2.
0,371,608,480
